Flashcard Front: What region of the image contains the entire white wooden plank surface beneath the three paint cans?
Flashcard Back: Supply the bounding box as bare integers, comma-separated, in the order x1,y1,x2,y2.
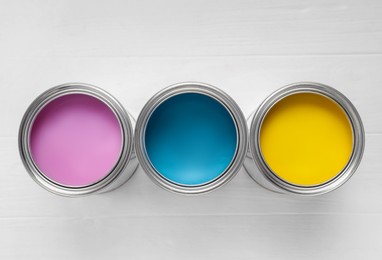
0,0,382,259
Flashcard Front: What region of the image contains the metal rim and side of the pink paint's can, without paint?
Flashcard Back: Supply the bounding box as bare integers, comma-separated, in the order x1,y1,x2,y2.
19,83,138,197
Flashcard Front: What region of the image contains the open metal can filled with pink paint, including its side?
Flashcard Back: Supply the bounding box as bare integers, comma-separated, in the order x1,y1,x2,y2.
19,83,138,197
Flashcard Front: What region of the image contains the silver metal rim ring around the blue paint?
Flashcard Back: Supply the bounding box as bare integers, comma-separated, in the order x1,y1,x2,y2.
134,82,248,195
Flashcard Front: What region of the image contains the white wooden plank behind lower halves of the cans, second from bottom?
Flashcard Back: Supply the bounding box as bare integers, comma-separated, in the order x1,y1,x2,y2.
0,135,382,218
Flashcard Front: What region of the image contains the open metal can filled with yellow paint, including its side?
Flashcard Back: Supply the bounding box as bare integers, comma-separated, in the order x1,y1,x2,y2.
244,82,365,195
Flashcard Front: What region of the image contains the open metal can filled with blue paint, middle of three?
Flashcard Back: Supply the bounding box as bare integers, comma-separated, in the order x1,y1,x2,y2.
135,82,247,194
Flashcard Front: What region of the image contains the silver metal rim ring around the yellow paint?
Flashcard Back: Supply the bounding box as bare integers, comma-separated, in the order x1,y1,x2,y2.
249,82,365,195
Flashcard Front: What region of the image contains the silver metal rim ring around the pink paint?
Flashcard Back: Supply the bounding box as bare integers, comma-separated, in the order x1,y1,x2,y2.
18,83,134,197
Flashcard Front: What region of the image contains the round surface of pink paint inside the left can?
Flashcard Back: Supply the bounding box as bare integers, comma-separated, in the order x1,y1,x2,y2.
30,94,122,186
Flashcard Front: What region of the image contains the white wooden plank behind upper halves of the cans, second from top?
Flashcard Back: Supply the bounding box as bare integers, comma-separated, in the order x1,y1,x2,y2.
0,55,382,137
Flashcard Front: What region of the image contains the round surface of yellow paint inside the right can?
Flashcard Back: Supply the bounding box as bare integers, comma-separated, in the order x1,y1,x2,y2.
260,93,353,186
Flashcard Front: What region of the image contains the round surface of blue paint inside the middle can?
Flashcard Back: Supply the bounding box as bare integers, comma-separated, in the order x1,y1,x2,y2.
145,93,237,186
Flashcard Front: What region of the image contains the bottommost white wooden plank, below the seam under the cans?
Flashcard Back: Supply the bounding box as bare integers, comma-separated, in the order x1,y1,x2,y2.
0,214,382,260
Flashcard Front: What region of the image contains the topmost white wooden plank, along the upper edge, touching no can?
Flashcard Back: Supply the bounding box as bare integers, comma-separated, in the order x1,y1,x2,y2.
0,0,382,58
